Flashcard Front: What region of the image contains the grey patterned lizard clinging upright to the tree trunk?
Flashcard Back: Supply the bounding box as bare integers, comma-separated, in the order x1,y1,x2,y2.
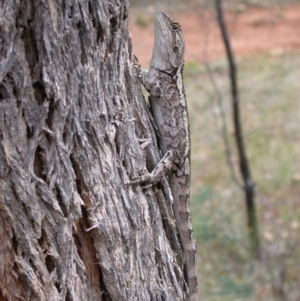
131,11,198,301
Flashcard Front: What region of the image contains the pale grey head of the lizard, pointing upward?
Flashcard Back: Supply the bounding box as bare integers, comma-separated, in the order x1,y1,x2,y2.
150,11,184,73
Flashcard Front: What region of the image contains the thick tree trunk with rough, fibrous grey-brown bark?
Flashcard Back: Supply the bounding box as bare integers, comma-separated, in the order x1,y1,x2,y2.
0,0,187,301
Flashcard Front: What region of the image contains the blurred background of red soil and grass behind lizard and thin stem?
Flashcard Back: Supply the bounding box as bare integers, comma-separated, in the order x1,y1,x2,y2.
130,0,300,301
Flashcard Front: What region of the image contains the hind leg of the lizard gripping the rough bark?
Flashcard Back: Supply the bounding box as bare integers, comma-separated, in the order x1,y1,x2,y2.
127,151,174,189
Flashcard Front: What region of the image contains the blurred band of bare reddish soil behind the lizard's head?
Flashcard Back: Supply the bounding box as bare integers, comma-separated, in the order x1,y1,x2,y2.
130,4,300,67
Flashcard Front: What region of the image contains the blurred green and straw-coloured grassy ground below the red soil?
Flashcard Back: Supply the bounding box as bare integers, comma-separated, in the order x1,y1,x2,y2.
189,53,300,301
